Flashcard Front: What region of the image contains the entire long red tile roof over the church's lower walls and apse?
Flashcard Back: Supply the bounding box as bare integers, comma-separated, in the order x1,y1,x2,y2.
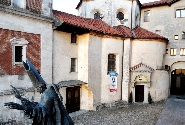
53,10,167,40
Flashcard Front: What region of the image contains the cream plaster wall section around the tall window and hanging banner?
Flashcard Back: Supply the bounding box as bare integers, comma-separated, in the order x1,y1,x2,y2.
101,38,123,103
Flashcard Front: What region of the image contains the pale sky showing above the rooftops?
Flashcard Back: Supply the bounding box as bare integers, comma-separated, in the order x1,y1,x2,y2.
53,0,158,15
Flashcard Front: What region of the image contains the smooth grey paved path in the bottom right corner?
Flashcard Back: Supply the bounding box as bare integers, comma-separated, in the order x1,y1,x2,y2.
156,96,185,125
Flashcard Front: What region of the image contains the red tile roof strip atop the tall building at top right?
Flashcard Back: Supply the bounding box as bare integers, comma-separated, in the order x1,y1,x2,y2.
141,0,179,8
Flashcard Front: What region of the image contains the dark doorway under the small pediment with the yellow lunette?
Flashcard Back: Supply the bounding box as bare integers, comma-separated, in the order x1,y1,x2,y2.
135,85,144,102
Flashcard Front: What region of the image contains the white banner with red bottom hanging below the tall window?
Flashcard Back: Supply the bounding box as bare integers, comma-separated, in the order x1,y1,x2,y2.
109,71,117,95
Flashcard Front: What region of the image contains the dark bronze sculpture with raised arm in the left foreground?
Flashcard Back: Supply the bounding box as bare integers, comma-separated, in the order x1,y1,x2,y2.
5,59,74,125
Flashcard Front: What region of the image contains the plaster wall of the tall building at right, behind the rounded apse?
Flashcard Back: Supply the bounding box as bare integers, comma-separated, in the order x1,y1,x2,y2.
141,0,185,66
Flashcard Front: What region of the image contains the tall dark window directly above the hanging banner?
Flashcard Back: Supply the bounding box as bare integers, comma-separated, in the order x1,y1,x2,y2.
108,54,116,71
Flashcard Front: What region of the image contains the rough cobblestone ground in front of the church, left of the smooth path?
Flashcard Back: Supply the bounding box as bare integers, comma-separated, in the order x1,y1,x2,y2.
72,101,165,125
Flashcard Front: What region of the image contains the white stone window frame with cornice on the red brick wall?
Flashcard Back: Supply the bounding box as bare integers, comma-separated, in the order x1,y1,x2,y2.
10,38,29,65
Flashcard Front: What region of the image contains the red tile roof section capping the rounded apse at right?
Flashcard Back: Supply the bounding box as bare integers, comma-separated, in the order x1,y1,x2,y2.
132,26,168,40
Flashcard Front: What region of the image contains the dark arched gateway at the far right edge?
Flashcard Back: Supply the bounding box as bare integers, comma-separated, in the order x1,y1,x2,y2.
170,69,185,95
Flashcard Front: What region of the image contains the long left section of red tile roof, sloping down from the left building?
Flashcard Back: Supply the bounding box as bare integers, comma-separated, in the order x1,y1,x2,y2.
53,10,124,36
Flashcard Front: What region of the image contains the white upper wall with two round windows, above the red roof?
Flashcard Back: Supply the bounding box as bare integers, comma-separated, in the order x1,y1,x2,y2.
78,0,139,27
